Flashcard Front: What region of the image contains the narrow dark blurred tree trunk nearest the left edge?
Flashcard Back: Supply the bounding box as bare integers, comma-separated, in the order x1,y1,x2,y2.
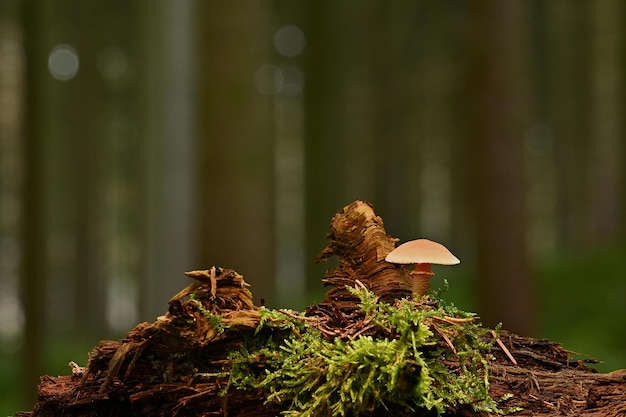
19,1,47,402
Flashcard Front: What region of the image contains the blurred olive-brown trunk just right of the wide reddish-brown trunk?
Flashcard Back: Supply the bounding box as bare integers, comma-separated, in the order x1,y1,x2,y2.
543,0,591,246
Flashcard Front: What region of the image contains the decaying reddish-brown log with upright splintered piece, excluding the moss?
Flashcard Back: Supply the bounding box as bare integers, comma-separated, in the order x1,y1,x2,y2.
16,201,626,417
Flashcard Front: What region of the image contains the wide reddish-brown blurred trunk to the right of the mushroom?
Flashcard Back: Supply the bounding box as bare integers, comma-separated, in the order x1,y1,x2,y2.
467,1,533,334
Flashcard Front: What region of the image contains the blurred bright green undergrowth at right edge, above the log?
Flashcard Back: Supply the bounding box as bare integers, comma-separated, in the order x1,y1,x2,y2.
536,242,626,372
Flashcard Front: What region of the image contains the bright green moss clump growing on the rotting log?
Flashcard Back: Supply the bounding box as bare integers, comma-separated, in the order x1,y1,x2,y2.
224,283,501,417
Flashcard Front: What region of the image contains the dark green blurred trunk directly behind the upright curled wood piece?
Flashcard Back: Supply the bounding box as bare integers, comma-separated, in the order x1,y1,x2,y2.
304,2,361,294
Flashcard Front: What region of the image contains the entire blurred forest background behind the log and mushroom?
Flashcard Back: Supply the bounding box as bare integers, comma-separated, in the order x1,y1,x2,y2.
0,0,626,415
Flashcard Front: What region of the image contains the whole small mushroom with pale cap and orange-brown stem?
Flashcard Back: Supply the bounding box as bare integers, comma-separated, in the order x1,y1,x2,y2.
385,239,461,298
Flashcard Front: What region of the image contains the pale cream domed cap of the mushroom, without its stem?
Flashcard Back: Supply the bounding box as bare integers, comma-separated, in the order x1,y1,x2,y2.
385,239,461,265
